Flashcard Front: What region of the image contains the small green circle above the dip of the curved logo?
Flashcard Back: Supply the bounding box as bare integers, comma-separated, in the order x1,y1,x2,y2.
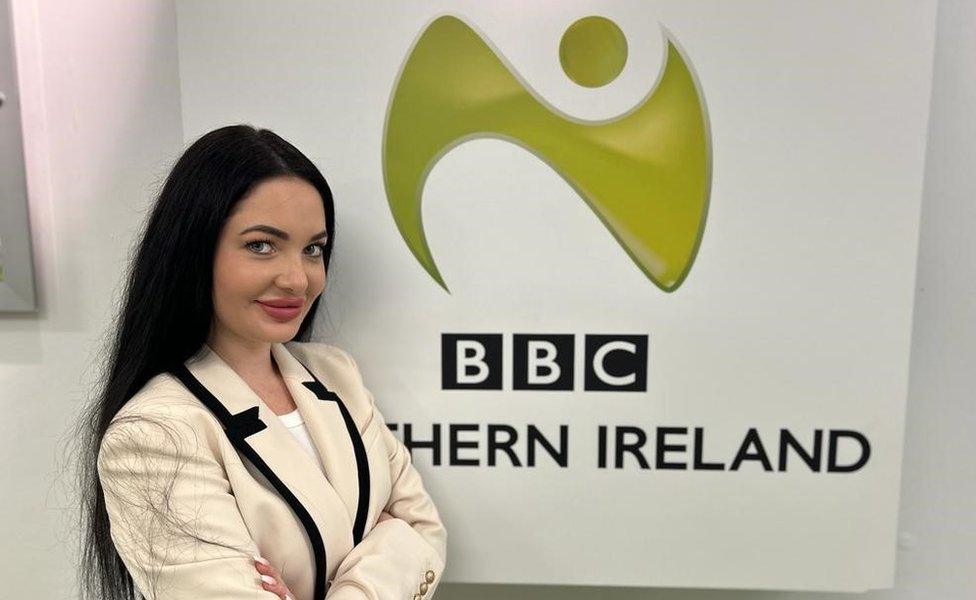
559,16,627,87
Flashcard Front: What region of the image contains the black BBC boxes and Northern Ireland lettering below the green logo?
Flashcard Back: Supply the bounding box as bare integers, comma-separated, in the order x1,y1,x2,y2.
428,334,871,473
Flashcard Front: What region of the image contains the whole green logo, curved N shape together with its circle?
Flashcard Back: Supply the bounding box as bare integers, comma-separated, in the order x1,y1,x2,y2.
383,16,711,292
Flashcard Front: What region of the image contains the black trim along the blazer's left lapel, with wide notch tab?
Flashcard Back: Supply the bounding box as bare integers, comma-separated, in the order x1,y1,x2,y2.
174,365,328,600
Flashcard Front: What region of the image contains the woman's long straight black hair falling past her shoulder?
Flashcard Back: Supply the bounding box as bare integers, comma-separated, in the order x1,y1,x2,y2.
69,124,335,600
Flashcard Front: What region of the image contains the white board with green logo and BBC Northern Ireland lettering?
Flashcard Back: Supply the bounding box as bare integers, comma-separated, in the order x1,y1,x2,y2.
178,0,935,591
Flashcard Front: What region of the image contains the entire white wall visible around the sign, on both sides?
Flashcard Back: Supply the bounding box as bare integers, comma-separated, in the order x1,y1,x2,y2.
0,0,976,600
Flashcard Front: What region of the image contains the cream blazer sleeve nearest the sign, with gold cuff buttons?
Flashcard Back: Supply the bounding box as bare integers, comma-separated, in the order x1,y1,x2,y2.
326,351,447,600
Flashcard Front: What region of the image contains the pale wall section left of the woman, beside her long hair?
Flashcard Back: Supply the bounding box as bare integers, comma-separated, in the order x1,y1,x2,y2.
0,0,183,600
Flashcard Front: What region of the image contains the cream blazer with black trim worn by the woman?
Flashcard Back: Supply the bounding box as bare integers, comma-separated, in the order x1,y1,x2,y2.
98,342,447,600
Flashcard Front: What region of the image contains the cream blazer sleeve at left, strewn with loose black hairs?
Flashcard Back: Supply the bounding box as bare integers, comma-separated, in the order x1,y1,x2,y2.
98,404,278,600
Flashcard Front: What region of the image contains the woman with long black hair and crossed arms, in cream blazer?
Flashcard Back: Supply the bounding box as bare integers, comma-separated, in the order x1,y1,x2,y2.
77,125,447,600
